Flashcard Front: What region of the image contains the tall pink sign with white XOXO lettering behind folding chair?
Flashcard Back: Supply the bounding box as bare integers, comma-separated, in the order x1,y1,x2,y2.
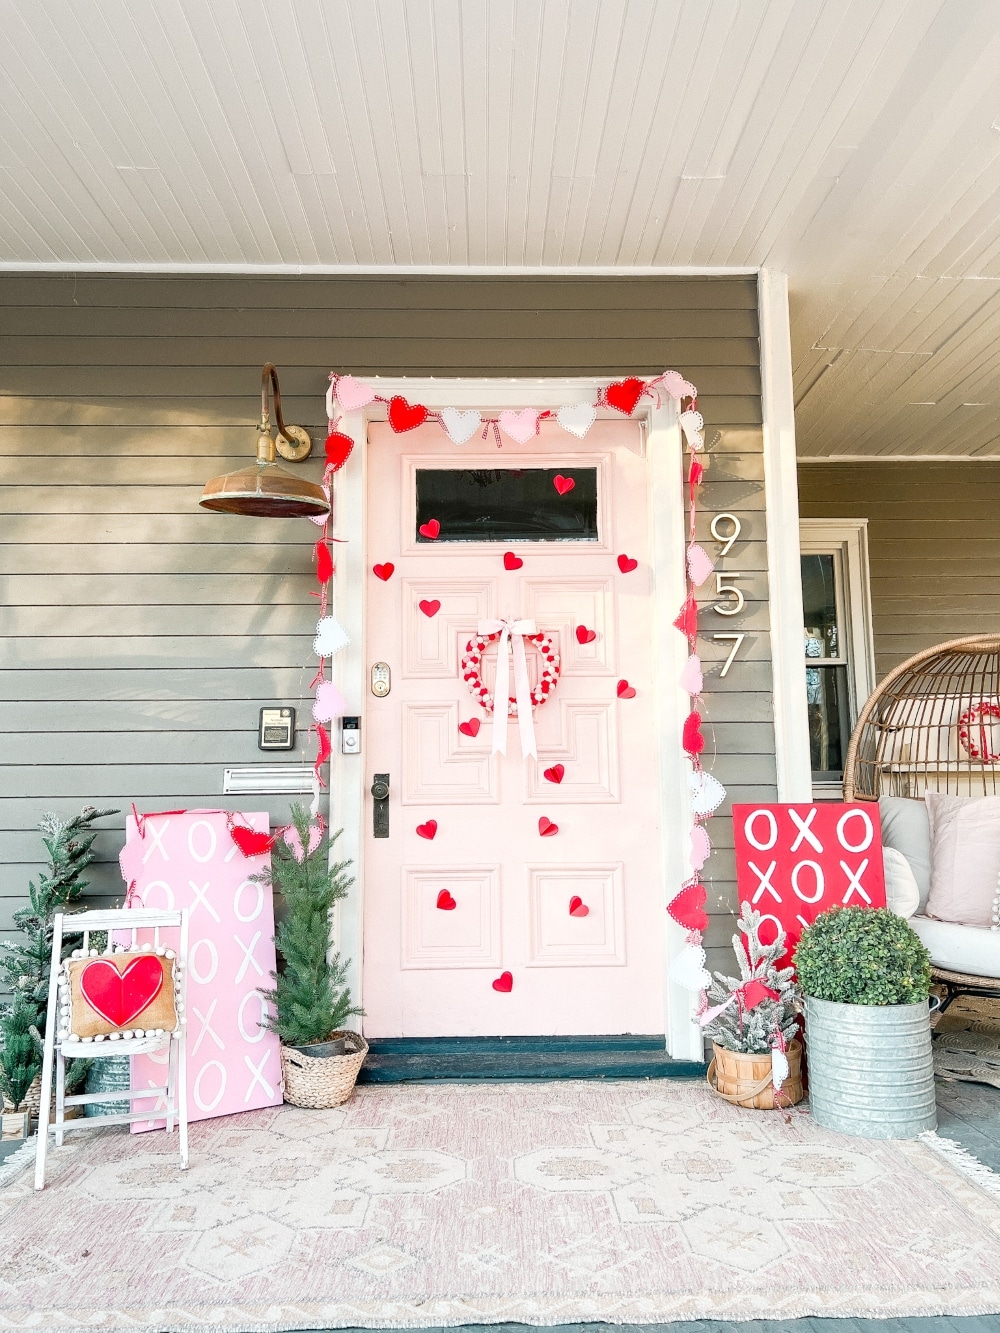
120,810,281,1132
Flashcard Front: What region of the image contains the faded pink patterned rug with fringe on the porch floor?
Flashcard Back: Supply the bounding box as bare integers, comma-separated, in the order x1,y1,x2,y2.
0,1081,1000,1333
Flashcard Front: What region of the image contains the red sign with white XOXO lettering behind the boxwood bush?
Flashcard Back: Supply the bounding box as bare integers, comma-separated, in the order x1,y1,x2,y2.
732,801,885,966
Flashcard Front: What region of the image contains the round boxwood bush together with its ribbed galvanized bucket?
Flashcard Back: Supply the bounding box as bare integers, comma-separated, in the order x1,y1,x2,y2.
795,906,937,1138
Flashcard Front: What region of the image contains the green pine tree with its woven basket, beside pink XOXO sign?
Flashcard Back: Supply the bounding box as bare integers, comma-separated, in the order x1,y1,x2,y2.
261,805,368,1109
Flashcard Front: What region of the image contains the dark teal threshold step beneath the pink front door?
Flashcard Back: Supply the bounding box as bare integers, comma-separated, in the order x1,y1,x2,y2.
357,1036,705,1084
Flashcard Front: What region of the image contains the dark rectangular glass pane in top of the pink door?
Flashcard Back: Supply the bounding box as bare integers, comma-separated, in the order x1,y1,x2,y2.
415,468,597,543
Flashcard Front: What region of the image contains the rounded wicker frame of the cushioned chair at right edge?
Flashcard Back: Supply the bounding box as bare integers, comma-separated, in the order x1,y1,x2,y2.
844,635,1000,1008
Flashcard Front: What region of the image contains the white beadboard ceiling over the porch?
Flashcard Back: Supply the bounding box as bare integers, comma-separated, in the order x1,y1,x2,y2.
0,0,1000,457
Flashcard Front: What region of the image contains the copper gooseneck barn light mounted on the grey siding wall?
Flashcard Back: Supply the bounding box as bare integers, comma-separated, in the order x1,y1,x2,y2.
199,361,329,519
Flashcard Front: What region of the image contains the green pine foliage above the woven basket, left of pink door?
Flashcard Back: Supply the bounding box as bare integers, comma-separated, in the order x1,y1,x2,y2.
261,805,361,1046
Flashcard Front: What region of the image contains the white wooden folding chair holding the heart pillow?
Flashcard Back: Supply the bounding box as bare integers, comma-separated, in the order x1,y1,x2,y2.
35,908,188,1189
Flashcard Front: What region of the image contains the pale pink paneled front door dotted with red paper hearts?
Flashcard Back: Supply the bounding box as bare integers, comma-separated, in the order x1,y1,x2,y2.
363,421,664,1037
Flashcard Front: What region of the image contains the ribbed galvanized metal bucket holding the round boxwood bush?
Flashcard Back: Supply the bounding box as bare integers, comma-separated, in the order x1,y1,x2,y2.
805,996,937,1138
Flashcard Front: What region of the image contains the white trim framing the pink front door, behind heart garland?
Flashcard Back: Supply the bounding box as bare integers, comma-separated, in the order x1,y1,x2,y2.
329,377,703,1060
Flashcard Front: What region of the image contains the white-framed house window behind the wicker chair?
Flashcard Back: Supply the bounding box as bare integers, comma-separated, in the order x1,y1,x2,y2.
800,519,875,798
